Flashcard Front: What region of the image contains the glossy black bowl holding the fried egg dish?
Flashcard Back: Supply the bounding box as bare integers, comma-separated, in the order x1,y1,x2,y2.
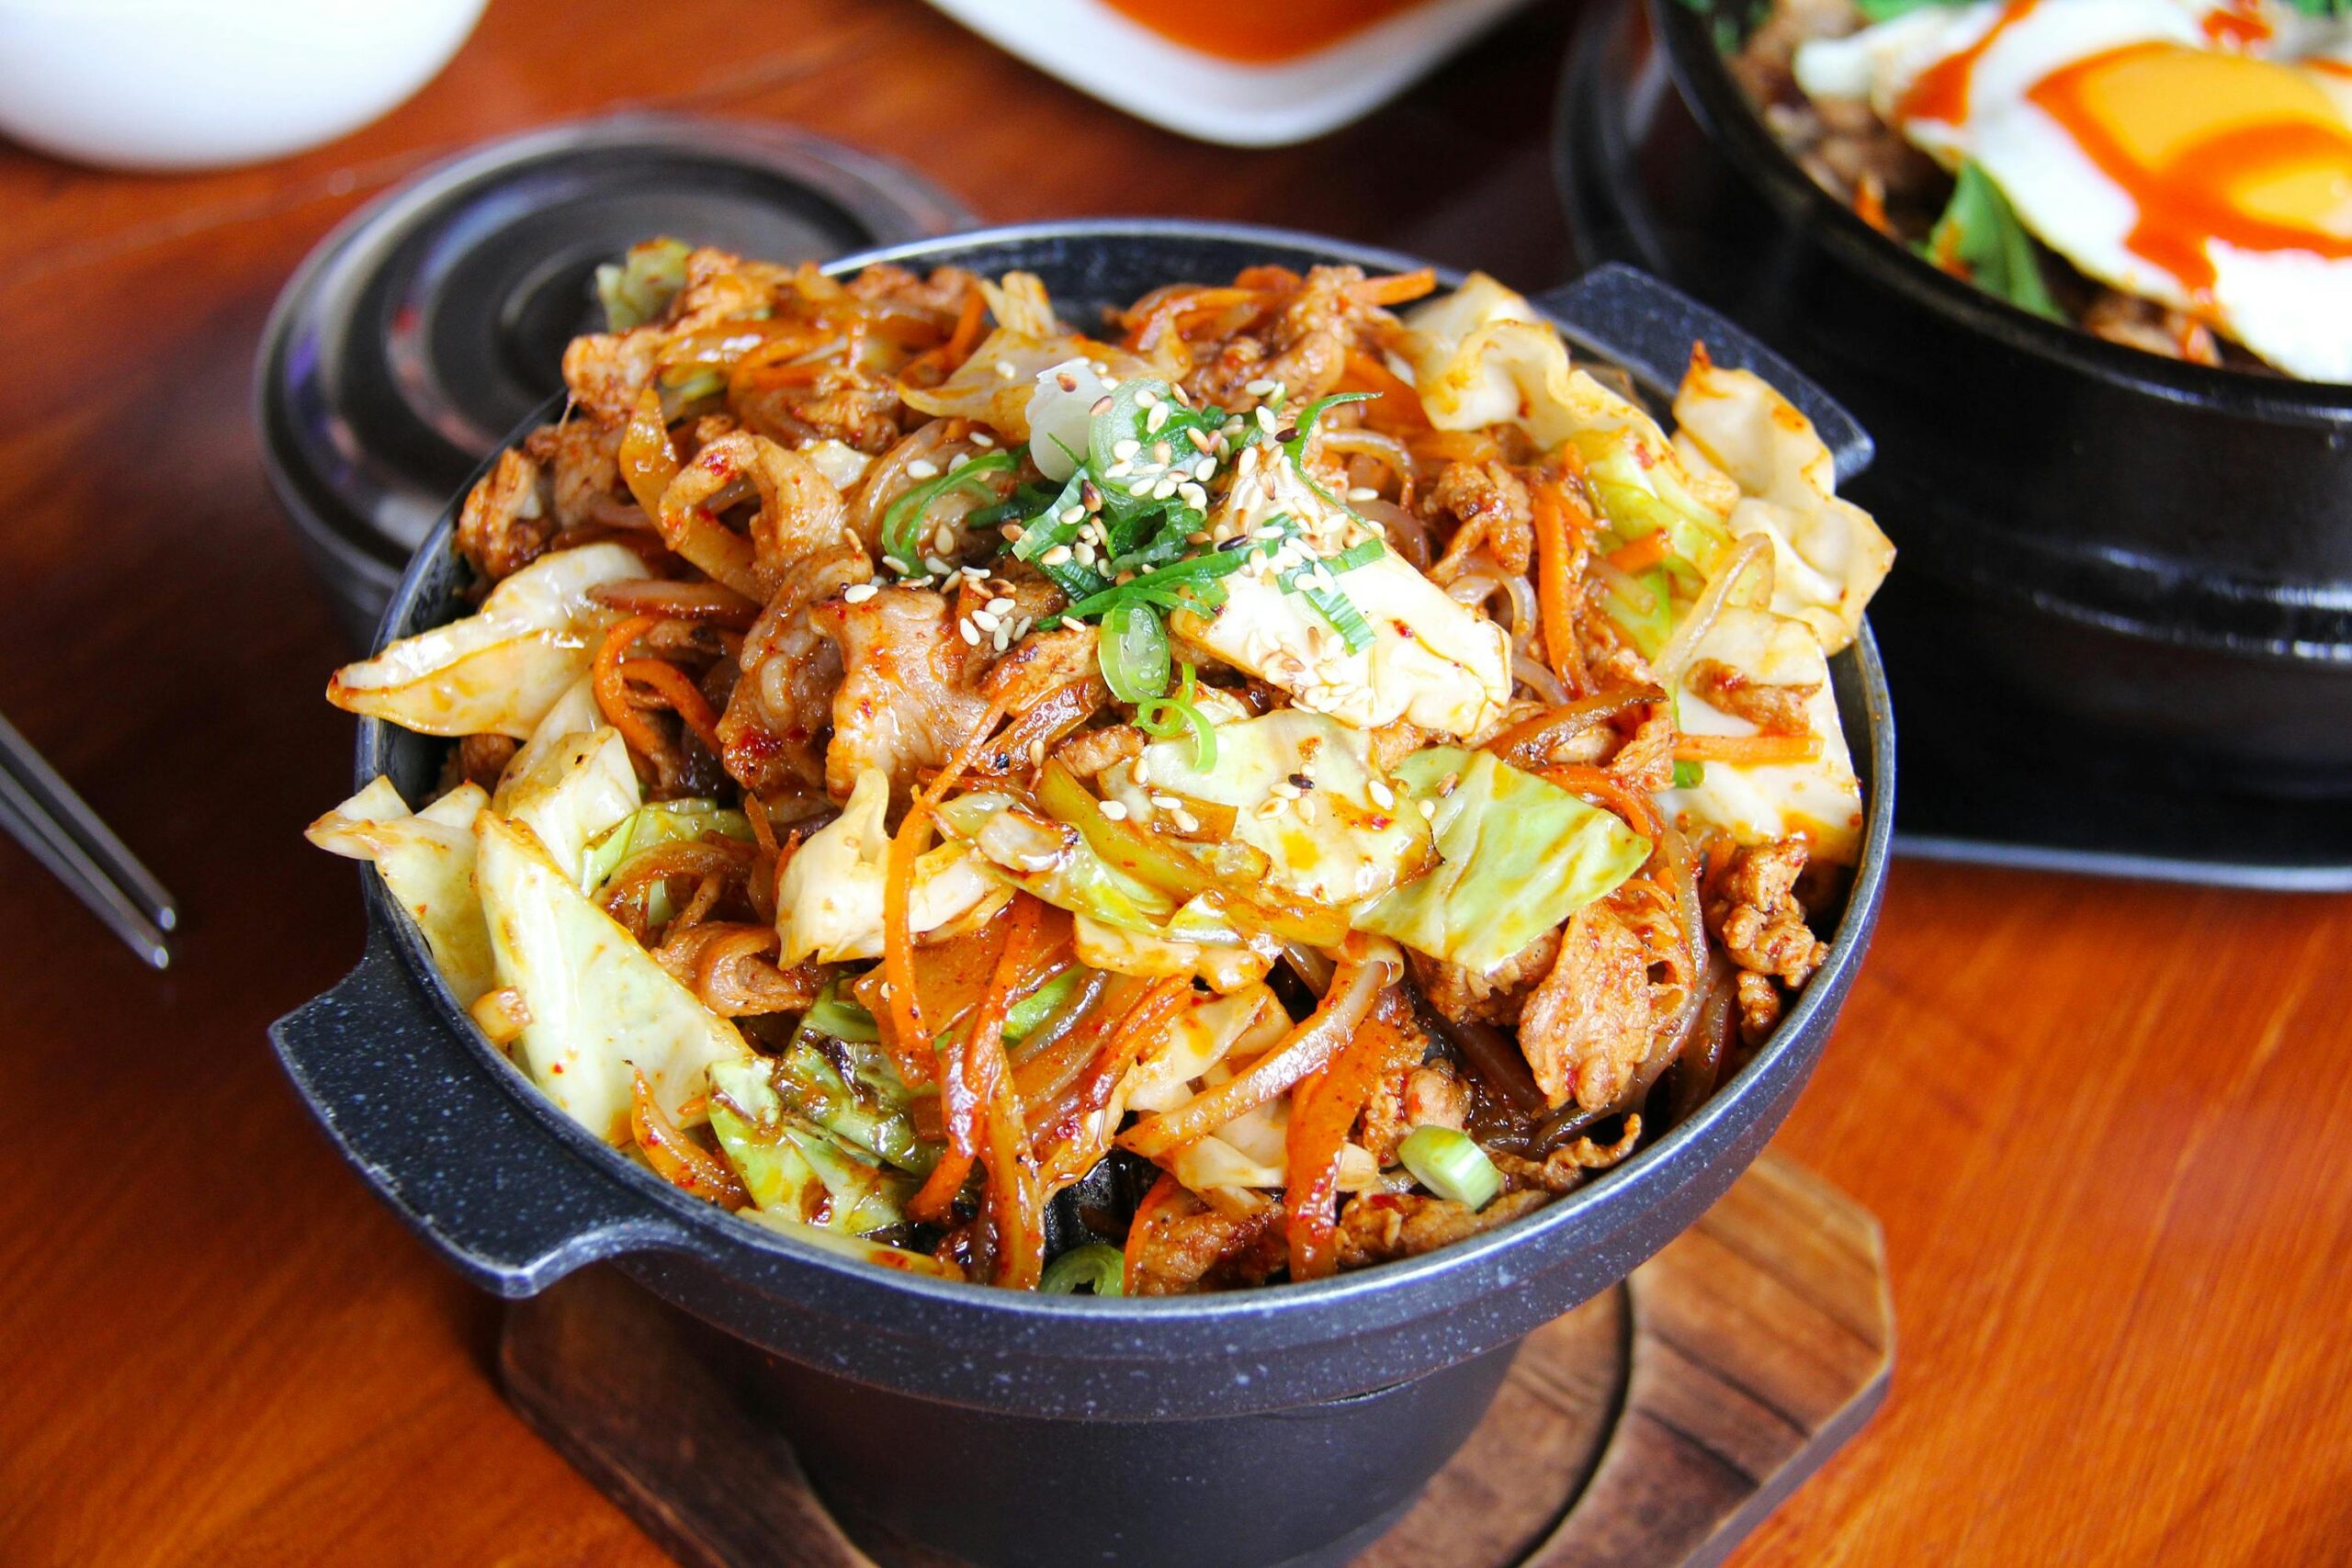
1557,0,2352,795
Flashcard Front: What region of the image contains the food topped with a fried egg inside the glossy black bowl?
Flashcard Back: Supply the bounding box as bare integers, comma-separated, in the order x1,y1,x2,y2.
1731,0,2352,381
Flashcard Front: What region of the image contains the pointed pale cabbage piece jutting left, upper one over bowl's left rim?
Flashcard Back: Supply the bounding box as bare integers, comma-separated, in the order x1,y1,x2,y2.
327,546,644,740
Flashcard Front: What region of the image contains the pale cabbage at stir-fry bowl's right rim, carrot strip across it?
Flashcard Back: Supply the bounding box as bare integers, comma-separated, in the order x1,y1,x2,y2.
1660,606,1863,865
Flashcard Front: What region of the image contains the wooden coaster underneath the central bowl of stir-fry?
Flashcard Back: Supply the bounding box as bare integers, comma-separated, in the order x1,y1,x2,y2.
499,1155,1894,1568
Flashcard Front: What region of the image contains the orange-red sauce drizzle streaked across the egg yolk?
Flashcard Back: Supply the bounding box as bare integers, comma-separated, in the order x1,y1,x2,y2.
2025,42,2352,296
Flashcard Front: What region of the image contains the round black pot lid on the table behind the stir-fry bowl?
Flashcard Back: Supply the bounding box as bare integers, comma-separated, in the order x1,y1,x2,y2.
256,115,969,602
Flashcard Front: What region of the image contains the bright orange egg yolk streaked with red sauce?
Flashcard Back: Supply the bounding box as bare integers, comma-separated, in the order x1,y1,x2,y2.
2025,42,2352,294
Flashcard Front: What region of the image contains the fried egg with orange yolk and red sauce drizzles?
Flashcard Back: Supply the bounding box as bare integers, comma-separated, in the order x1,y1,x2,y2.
1797,0,2352,381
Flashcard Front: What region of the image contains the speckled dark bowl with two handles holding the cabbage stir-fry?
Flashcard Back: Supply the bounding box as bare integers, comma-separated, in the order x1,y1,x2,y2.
270,221,1894,1568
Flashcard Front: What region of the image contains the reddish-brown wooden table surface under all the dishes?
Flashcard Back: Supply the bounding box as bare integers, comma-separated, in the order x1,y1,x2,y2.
0,0,2352,1563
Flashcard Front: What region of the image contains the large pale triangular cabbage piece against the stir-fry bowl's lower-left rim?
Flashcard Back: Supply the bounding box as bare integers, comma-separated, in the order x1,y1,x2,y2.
475,811,751,1143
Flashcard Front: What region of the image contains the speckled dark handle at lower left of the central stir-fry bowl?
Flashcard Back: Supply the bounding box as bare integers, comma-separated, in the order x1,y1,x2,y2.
270,933,687,1295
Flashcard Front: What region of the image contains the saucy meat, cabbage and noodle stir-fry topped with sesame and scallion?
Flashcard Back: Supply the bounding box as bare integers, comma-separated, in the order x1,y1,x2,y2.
311,243,1891,1293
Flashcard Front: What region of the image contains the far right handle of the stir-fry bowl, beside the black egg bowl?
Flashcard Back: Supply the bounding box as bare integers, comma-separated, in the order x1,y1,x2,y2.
1536,261,1877,484
